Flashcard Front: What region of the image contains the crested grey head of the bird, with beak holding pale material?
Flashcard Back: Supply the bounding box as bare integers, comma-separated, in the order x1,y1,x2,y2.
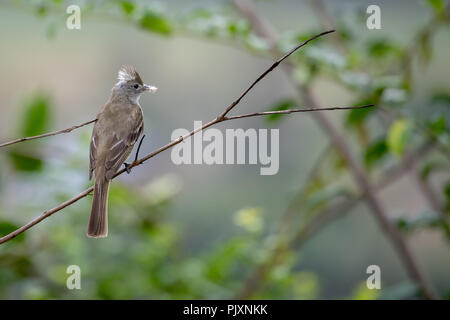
113,66,157,102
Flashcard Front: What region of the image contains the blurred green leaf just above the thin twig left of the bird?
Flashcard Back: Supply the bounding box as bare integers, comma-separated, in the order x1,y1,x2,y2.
20,94,52,137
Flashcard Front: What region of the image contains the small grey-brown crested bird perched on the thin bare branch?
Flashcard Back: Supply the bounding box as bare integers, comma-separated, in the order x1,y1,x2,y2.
87,65,157,238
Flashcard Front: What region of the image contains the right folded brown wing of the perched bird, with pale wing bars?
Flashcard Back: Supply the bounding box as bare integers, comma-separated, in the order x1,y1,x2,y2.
105,110,144,180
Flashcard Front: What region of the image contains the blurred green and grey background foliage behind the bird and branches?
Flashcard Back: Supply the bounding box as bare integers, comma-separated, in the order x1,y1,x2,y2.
0,0,450,299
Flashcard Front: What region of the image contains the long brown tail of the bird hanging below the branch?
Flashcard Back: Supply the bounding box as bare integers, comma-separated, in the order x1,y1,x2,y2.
87,178,110,238
